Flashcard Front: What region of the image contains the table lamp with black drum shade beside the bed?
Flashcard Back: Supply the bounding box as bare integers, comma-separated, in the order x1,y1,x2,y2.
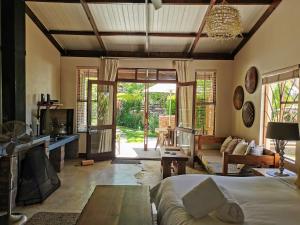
266,122,299,177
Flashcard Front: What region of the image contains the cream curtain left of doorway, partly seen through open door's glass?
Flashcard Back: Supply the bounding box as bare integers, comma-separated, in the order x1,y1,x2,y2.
97,59,119,153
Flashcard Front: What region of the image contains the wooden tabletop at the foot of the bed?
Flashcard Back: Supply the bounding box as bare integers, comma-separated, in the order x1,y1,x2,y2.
76,185,152,225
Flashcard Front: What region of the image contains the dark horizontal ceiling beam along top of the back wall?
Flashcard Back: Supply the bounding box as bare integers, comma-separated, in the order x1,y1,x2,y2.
62,50,233,60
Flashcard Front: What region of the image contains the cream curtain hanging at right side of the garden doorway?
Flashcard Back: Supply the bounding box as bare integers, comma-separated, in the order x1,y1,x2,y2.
174,61,195,128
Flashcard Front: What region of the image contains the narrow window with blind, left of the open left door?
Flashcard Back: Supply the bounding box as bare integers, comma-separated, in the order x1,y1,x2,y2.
76,68,98,132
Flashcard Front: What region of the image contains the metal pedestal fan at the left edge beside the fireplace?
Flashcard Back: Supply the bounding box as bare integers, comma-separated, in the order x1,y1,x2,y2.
0,121,32,225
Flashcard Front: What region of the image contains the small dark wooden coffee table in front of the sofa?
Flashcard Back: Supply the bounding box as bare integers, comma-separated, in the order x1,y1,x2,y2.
160,147,189,179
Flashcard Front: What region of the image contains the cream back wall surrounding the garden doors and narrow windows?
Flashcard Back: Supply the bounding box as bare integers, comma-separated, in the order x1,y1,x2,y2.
61,57,233,152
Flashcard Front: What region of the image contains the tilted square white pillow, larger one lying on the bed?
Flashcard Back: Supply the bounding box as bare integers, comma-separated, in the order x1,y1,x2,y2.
182,177,226,218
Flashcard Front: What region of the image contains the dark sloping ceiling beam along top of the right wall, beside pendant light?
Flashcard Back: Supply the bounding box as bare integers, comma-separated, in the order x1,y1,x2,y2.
232,0,281,56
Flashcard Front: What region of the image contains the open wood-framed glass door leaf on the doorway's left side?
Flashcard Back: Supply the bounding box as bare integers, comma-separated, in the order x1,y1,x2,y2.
87,81,116,160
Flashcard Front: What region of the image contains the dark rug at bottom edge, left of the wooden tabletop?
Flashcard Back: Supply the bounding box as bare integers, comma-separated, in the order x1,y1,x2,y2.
26,212,80,225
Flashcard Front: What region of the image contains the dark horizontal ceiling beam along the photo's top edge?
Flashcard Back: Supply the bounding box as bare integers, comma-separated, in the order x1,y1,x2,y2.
25,0,273,5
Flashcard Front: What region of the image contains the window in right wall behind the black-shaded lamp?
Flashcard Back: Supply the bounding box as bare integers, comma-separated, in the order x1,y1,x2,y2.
263,66,299,160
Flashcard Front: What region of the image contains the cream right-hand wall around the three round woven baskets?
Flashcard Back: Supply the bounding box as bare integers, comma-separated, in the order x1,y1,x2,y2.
231,0,300,169
